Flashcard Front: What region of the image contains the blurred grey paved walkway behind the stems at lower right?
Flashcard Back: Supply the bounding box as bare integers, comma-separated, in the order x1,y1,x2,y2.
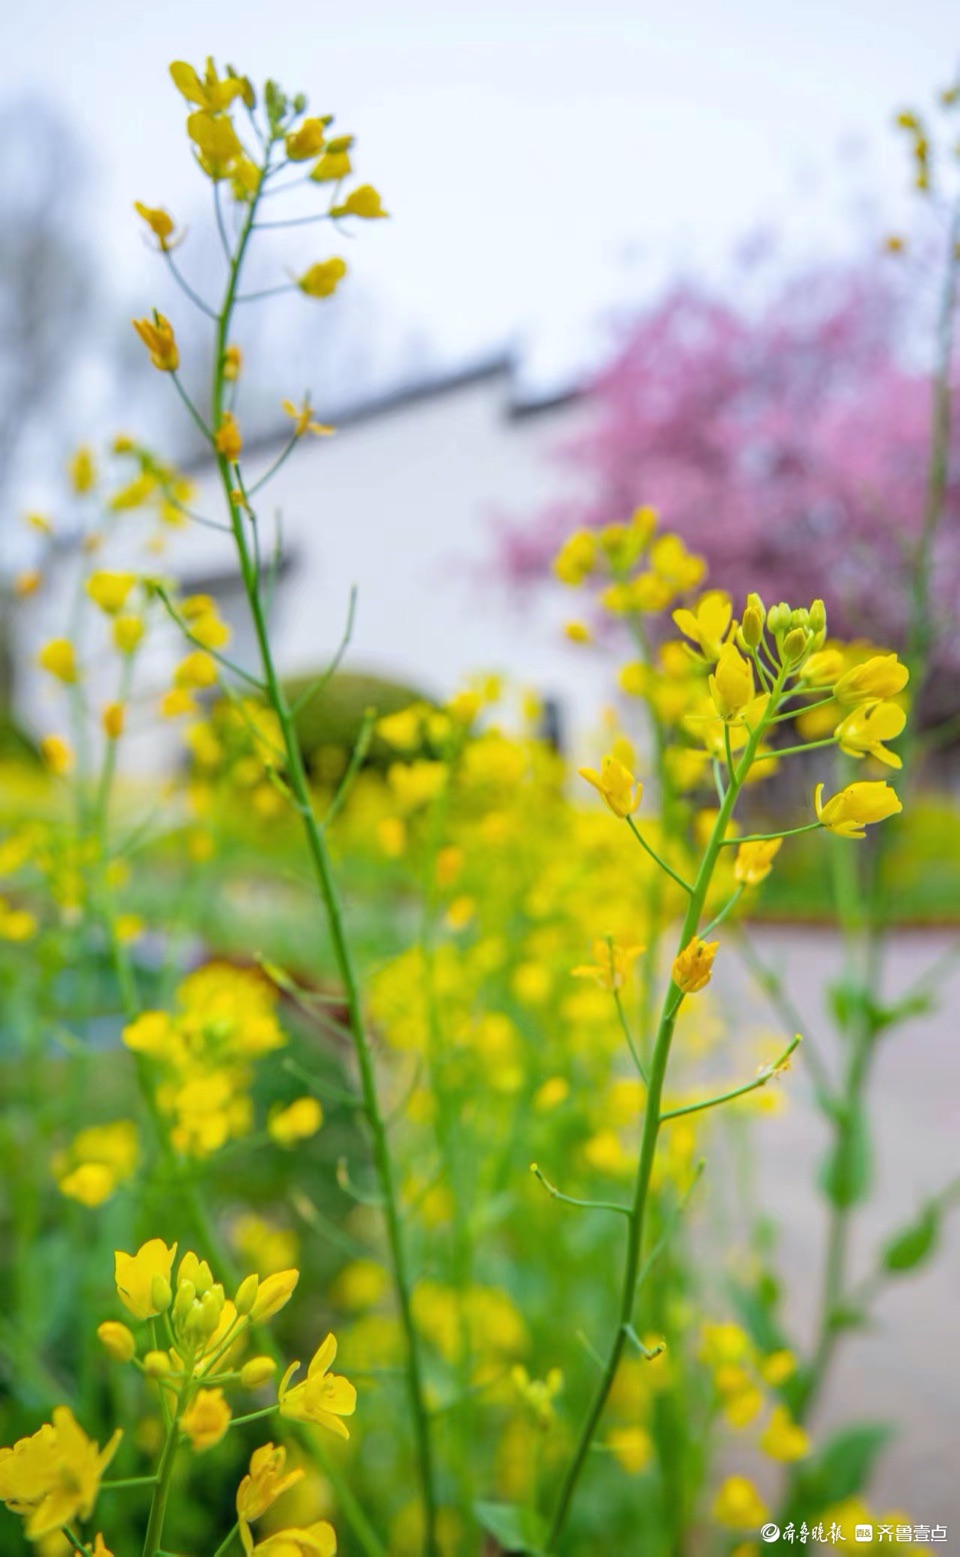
717,928,960,1532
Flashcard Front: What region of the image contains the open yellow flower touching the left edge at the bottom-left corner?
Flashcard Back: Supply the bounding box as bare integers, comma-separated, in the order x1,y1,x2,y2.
0,1406,123,1541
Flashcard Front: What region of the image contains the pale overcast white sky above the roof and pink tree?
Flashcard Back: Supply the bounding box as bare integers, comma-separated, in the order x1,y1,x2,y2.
0,0,960,387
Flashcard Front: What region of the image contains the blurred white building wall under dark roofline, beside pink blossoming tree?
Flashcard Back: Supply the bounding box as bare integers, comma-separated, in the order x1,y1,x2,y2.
19,372,622,768
